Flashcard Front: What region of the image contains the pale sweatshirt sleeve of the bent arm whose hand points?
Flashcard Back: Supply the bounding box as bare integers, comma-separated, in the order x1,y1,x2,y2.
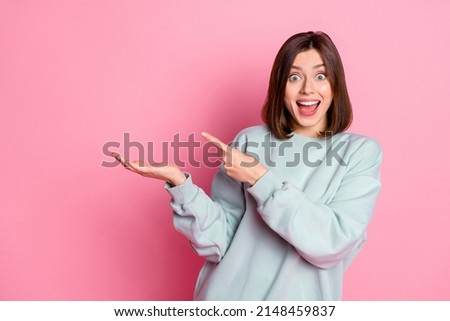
248,140,382,268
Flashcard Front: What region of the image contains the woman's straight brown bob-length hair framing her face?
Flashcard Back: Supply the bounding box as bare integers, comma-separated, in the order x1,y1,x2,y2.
262,31,353,139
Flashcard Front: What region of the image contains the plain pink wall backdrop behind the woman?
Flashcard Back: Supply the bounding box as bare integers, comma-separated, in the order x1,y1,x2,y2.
0,0,450,300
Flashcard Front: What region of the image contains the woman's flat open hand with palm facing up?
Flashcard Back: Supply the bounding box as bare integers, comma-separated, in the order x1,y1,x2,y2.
111,153,186,186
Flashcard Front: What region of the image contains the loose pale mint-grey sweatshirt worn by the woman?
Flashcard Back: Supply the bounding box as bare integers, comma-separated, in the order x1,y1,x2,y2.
166,126,382,300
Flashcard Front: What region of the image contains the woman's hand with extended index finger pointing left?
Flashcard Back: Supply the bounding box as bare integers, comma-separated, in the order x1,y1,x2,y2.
202,133,267,185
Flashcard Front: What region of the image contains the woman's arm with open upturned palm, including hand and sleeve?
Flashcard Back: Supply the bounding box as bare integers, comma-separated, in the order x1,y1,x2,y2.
112,135,250,262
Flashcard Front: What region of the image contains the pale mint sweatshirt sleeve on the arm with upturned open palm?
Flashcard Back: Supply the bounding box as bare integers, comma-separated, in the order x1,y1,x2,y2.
166,167,245,262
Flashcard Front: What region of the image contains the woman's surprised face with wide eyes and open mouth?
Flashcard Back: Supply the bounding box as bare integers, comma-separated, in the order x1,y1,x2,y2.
284,49,333,137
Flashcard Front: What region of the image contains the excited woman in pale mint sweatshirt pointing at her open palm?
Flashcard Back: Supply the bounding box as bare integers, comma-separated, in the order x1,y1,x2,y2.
114,32,382,300
